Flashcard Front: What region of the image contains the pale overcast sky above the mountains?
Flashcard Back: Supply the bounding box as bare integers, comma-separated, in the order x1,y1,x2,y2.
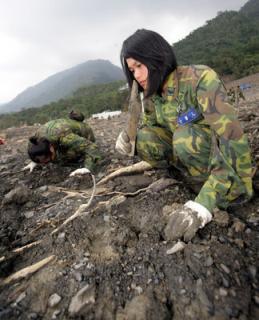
0,0,247,103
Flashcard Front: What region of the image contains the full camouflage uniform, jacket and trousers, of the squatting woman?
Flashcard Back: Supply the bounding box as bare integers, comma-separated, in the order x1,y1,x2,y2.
136,66,253,211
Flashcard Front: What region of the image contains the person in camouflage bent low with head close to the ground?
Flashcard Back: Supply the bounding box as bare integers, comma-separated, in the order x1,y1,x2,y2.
24,113,101,175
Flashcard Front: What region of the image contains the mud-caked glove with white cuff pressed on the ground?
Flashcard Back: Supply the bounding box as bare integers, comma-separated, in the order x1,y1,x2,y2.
165,201,212,241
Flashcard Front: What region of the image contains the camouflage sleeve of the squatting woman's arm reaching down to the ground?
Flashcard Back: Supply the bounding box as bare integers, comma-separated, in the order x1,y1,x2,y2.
195,69,253,211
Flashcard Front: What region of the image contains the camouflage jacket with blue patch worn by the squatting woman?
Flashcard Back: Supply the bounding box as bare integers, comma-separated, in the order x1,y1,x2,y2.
143,66,253,210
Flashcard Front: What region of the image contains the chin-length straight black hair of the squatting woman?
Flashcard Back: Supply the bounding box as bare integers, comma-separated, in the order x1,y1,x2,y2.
120,29,177,97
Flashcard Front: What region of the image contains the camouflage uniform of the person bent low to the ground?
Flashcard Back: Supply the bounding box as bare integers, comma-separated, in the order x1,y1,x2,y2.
32,119,101,170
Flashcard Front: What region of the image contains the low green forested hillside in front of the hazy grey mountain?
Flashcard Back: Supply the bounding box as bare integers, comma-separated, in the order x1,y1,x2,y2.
0,81,128,129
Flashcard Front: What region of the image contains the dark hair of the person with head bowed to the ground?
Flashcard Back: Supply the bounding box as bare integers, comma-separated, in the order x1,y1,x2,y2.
28,136,51,162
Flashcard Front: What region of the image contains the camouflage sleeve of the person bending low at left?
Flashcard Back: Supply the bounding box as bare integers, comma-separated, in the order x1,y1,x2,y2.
60,133,101,171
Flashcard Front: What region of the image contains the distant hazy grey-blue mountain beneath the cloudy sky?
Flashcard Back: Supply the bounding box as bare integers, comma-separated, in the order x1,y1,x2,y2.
0,60,125,113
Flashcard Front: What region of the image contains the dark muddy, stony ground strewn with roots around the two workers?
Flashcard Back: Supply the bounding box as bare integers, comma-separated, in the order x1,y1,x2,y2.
0,77,259,320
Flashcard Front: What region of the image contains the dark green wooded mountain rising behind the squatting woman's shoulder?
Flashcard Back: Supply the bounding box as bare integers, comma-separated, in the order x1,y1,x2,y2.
174,0,259,78
